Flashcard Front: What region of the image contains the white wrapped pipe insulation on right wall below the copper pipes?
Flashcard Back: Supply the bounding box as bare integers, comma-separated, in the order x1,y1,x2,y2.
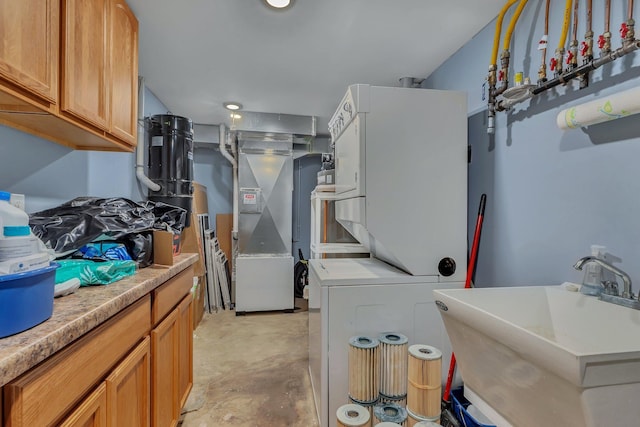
556,87,640,130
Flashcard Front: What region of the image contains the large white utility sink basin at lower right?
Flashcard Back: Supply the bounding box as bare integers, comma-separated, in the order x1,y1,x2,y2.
433,286,640,427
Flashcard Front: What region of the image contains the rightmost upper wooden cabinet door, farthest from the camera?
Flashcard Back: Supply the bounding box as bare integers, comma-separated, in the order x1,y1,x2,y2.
109,0,138,145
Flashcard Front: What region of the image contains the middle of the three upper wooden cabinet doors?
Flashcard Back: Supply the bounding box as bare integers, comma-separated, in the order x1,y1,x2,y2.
61,0,109,130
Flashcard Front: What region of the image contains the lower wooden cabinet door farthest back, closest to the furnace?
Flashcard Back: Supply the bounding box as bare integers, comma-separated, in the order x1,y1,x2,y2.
178,294,193,408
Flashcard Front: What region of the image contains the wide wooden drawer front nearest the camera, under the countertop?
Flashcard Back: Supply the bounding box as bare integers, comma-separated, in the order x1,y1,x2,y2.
4,297,150,427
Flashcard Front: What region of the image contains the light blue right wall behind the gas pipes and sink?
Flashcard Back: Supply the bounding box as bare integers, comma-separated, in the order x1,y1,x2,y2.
423,2,640,290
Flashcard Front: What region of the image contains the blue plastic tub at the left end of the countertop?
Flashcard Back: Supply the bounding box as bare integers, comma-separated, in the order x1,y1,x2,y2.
0,262,60,338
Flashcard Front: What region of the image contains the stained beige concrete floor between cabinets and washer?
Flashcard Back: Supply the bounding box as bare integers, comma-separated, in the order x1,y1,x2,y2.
182,310,318,427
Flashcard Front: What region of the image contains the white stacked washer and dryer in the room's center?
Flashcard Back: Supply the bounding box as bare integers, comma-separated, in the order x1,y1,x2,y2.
309,84,468,427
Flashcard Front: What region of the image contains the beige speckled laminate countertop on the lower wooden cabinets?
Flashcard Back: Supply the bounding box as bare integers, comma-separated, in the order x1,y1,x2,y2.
0,254,198,386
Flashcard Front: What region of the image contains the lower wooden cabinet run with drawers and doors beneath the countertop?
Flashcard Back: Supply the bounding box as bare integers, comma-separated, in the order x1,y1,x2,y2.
0,267,193,427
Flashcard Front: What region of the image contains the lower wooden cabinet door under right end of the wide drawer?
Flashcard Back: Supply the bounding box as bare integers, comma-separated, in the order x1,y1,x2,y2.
105,337,151,427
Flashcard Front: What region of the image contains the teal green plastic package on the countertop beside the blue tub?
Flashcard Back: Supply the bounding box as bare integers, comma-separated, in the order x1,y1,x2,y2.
56,259,136,286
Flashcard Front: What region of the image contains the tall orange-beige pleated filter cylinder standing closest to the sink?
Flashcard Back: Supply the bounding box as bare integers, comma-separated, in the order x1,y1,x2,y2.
407,344,442,420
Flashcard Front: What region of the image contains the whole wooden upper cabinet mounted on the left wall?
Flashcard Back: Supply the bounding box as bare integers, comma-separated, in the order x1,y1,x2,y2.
0,0,138,151
